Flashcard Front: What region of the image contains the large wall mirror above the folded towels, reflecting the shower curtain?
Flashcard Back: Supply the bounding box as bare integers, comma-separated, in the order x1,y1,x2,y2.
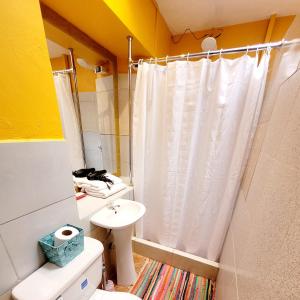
42,9,121,176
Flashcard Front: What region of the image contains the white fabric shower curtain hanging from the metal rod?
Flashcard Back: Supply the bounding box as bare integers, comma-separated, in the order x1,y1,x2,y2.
133,53,269,261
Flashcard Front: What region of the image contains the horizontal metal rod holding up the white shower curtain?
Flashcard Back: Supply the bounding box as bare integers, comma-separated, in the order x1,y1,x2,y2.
130,39,300,66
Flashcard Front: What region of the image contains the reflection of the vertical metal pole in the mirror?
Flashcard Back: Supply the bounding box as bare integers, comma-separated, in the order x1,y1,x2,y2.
68,48,86,168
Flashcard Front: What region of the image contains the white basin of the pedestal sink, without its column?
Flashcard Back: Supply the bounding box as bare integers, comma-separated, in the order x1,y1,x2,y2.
91,199,146,229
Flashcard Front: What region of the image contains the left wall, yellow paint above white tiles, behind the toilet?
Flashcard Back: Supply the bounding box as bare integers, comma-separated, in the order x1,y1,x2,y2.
0,0,78,300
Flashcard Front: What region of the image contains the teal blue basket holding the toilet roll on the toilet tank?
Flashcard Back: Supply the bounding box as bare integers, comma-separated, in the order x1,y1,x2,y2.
39,224,84,267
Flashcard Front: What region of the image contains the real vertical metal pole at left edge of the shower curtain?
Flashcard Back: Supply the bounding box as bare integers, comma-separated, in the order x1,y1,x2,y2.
127,36,133,185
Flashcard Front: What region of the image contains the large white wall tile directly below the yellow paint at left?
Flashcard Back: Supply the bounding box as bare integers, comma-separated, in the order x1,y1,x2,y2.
0,141,74,224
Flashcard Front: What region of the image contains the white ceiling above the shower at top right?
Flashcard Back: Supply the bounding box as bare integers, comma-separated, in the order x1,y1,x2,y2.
156,0,300,34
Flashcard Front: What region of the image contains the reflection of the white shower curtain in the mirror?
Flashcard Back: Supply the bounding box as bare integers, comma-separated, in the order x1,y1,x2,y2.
54,74,84,170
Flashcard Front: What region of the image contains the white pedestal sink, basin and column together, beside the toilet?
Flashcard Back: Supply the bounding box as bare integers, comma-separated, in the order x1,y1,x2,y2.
91,199,146,286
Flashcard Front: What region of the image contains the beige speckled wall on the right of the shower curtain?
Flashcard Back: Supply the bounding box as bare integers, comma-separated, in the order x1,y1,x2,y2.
216,17,300,300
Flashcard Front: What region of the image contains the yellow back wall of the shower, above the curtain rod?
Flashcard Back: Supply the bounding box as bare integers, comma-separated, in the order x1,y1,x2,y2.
170,16,294,55
